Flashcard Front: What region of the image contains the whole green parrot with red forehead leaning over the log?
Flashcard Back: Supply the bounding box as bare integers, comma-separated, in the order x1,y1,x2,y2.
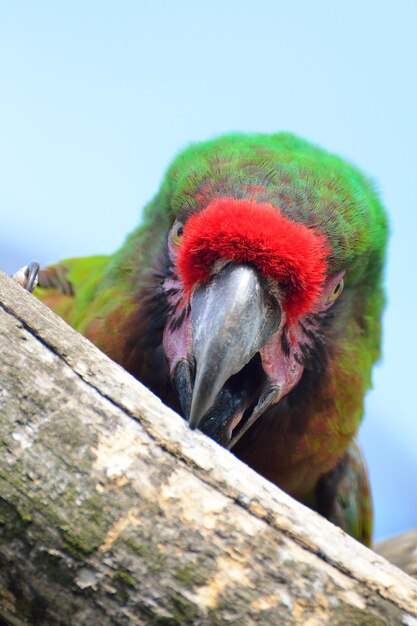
28,132,389,545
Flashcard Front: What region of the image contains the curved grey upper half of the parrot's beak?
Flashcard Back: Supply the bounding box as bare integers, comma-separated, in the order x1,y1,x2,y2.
189,263,281,428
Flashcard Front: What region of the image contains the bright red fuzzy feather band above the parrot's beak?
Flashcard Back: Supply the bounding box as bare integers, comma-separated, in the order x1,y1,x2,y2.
178,198,329,321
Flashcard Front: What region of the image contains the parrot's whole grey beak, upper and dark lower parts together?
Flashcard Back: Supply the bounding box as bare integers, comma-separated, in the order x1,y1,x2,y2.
189,263,281,445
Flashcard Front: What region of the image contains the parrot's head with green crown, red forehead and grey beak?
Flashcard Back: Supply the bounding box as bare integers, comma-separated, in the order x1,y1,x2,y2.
118,134,386,447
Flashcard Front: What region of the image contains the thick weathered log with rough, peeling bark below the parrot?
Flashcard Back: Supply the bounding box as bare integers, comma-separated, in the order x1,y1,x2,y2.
0,273,417,626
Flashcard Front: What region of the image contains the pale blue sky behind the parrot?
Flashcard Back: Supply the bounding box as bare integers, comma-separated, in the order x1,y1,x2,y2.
0,0,417,538
